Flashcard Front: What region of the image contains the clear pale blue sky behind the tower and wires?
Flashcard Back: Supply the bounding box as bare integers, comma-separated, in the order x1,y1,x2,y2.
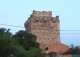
0,0,80,46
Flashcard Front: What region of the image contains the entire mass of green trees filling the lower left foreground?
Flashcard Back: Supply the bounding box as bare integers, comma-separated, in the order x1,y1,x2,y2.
0,28,46,57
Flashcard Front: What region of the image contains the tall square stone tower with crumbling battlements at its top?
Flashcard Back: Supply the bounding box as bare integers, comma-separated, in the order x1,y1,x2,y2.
24,10,60,49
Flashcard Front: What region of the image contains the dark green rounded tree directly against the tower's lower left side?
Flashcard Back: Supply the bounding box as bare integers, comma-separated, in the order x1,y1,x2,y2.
13,30,39,50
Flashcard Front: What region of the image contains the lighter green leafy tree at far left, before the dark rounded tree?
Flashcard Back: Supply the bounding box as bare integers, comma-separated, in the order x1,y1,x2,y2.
0,28,26,57
